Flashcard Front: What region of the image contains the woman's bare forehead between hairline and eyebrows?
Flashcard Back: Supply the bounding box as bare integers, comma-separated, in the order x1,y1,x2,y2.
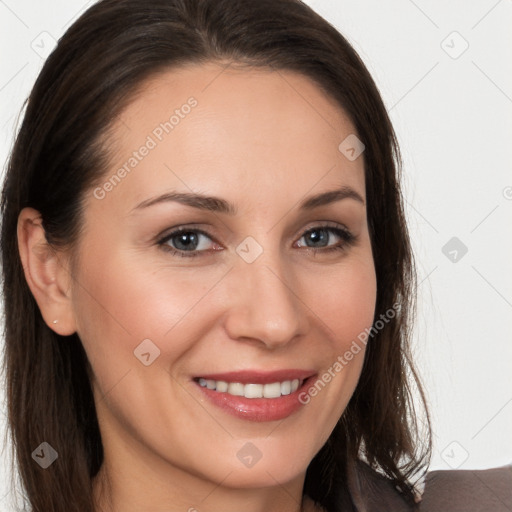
93,64,364,214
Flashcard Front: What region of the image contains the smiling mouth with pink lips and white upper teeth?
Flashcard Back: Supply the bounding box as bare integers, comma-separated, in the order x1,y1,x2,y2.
193,370,316,421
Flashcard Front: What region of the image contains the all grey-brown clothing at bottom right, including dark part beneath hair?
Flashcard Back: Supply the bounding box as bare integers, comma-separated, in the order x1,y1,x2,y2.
349,461,512,512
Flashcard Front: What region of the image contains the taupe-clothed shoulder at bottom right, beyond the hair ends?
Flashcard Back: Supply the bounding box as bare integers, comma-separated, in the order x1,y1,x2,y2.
420,465,512,512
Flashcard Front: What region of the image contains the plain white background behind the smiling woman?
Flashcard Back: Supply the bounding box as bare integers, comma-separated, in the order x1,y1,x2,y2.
0,0,512,510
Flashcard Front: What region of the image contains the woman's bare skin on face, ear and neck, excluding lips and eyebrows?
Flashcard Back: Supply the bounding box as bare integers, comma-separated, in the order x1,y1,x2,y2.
18,63,376,512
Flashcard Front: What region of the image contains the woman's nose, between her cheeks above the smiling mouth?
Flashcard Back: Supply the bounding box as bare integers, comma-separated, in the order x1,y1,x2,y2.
221,246,308,349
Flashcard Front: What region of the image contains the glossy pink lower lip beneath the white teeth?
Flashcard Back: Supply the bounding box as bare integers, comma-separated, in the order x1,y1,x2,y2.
196,377,312,421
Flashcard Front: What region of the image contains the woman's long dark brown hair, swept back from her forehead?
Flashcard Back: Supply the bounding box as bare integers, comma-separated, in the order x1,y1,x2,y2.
1,0,431,512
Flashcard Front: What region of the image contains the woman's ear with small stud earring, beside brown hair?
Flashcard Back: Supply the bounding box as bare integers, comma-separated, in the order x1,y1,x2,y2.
18,208,76,336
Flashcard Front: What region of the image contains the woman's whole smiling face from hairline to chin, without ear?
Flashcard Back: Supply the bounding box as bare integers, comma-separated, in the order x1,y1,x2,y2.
67,64,376,496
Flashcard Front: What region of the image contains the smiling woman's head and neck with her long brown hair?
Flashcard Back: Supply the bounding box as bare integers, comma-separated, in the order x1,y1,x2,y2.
2,0,510,512
